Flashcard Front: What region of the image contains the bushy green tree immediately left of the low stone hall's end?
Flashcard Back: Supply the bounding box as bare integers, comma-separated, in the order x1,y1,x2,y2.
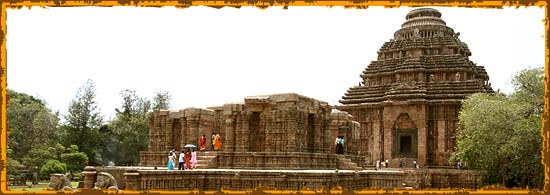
108,90,151,165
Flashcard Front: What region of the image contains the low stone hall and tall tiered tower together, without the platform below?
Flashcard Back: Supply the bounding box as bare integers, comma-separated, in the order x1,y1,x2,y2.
141,8,492,169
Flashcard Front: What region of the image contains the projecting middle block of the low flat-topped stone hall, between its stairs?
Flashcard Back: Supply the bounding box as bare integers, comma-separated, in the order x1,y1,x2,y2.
222,94,331,153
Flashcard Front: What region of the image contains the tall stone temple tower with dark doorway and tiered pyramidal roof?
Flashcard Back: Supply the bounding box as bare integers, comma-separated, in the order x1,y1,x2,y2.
337,8,492,167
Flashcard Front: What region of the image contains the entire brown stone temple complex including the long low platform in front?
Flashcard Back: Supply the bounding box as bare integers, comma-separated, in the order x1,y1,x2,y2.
94,8,493,190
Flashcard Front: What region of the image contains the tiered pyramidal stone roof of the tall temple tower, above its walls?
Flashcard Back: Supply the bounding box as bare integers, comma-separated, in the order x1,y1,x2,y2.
340,8,492,107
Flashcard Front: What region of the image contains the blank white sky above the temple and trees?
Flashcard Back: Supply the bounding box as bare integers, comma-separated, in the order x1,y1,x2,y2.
6,6,545,120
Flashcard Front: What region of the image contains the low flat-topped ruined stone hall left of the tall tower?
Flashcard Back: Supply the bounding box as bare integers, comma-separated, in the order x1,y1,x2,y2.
141,93,364,169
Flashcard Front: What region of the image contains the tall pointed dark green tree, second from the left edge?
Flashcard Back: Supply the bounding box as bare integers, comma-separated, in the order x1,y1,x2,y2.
62,80,102,165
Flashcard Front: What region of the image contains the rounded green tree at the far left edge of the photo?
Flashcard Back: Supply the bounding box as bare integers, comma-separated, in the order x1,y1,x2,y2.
7,89,60,161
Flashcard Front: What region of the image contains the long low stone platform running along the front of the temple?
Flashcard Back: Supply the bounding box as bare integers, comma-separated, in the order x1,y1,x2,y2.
85,167,481,191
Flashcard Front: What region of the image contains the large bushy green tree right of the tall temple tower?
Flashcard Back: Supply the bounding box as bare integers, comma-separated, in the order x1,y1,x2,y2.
450,68,544,188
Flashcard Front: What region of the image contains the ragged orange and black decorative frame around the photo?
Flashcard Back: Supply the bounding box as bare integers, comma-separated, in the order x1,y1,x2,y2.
0,0,550,195
